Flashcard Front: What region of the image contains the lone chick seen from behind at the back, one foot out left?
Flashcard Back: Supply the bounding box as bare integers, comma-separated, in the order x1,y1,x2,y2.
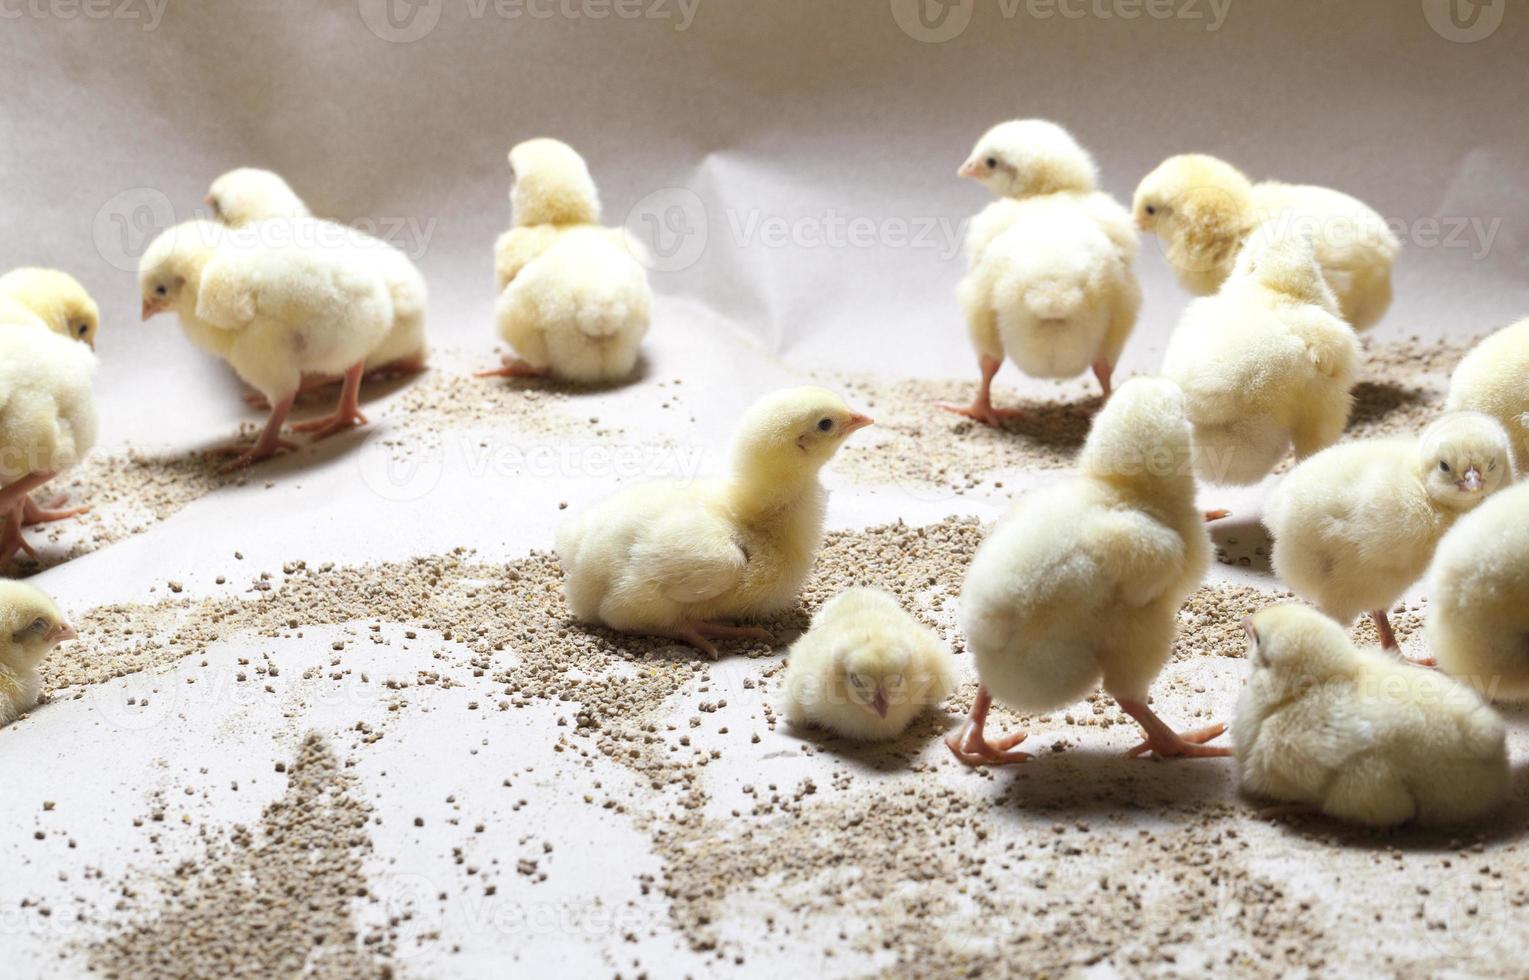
479,139,653,384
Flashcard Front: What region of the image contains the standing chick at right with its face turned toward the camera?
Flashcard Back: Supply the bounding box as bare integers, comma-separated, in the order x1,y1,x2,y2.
1263,411,1514,650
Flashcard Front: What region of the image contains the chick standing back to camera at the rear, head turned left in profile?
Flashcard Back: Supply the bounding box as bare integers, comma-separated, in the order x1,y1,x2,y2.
940,119,1141,425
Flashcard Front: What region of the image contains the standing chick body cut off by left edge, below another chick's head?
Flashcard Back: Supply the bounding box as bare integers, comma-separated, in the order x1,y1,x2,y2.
0,329,96,566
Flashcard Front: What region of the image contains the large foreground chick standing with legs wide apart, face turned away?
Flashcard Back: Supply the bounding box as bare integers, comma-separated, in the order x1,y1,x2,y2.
948,378,1231,766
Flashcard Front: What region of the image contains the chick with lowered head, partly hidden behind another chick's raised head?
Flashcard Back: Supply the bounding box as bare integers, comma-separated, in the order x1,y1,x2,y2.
1133,153,1402,330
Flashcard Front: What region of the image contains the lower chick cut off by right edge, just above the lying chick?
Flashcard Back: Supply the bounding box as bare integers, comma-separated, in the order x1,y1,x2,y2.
1428,482,1529,702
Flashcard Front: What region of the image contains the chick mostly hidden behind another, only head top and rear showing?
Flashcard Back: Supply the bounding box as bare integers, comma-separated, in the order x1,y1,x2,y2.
206,167,430,380
